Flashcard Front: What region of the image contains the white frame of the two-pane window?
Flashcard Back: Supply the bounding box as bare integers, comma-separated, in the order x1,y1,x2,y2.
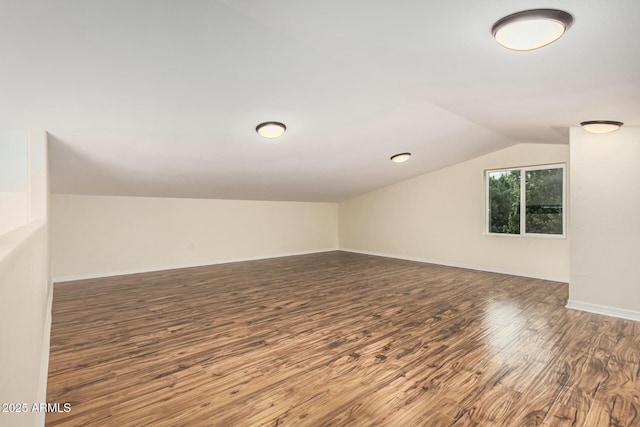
484,163,567,239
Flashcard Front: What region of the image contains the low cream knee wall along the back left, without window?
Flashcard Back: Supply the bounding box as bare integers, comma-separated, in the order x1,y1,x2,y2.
51,194,338,281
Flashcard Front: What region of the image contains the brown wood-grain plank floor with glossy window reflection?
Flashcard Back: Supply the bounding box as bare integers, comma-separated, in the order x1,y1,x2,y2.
46,252,640,427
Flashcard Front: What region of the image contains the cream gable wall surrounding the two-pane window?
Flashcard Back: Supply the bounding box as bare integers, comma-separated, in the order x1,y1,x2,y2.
339,144,569,282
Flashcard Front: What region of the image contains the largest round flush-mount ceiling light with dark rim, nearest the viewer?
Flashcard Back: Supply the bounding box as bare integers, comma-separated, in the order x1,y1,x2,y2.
491,9,573,51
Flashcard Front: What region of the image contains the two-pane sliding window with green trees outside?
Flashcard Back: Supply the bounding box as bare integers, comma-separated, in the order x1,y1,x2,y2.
486,165,565,236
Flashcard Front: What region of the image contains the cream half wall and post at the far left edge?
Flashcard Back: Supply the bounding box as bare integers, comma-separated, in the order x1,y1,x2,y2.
0,131,52,427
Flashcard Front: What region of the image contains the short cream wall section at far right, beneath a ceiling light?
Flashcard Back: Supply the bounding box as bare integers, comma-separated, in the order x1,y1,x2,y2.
568,127,640,320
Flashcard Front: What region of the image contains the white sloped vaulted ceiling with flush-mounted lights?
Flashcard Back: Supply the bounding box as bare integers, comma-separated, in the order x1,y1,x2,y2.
0,0,640,201
